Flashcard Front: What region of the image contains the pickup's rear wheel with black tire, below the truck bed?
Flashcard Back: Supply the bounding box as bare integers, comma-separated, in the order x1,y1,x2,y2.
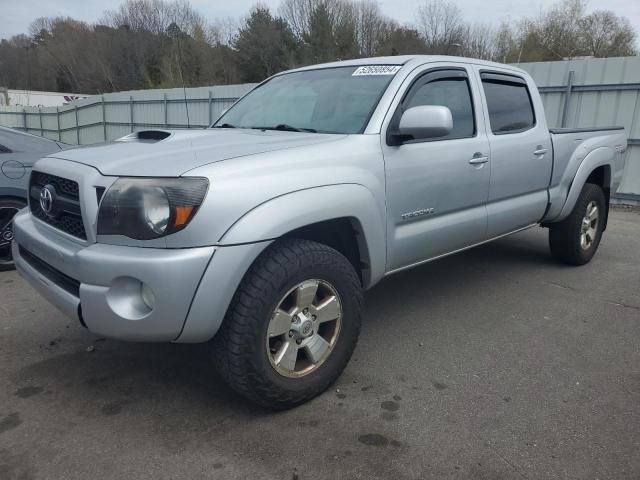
549,183,607,265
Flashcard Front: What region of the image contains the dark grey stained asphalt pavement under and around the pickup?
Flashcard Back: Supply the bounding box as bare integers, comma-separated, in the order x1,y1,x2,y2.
0,209,640,480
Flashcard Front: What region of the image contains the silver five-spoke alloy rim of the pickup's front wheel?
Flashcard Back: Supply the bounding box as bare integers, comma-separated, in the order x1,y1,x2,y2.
266,279,342,377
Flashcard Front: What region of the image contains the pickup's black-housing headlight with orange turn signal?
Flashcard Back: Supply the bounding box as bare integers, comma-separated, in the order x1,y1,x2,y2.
98,177,209,240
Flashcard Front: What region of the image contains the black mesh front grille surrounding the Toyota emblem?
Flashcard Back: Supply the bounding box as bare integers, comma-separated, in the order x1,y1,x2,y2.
29,171,87,240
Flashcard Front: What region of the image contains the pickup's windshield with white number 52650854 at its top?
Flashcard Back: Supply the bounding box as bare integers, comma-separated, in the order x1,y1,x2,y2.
213,65,400,134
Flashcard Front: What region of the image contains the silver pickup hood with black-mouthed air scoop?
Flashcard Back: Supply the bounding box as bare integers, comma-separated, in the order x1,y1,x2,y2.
49,129,345,177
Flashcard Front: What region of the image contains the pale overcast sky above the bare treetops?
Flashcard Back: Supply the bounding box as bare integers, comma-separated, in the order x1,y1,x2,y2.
0,0,640,38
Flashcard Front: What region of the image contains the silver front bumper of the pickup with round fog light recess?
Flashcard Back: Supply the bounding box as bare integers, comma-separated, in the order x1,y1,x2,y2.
13,209,215,341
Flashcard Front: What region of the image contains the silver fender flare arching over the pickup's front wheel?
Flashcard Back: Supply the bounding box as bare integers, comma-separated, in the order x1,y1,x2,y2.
218,183,386,287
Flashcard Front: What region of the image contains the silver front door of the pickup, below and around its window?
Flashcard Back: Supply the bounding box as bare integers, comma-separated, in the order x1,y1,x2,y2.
381,64,491,271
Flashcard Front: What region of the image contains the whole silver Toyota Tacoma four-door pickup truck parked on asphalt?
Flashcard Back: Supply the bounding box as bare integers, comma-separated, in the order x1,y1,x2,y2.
13,56,626,409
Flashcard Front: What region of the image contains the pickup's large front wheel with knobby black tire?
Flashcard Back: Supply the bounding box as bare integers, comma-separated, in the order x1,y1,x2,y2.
212,239,363,410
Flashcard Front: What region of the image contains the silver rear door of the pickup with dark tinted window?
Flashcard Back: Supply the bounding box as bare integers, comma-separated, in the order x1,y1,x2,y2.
476,67,553,238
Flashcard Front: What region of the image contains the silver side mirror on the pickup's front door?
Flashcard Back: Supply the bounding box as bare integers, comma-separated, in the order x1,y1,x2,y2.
393,105,453,144
